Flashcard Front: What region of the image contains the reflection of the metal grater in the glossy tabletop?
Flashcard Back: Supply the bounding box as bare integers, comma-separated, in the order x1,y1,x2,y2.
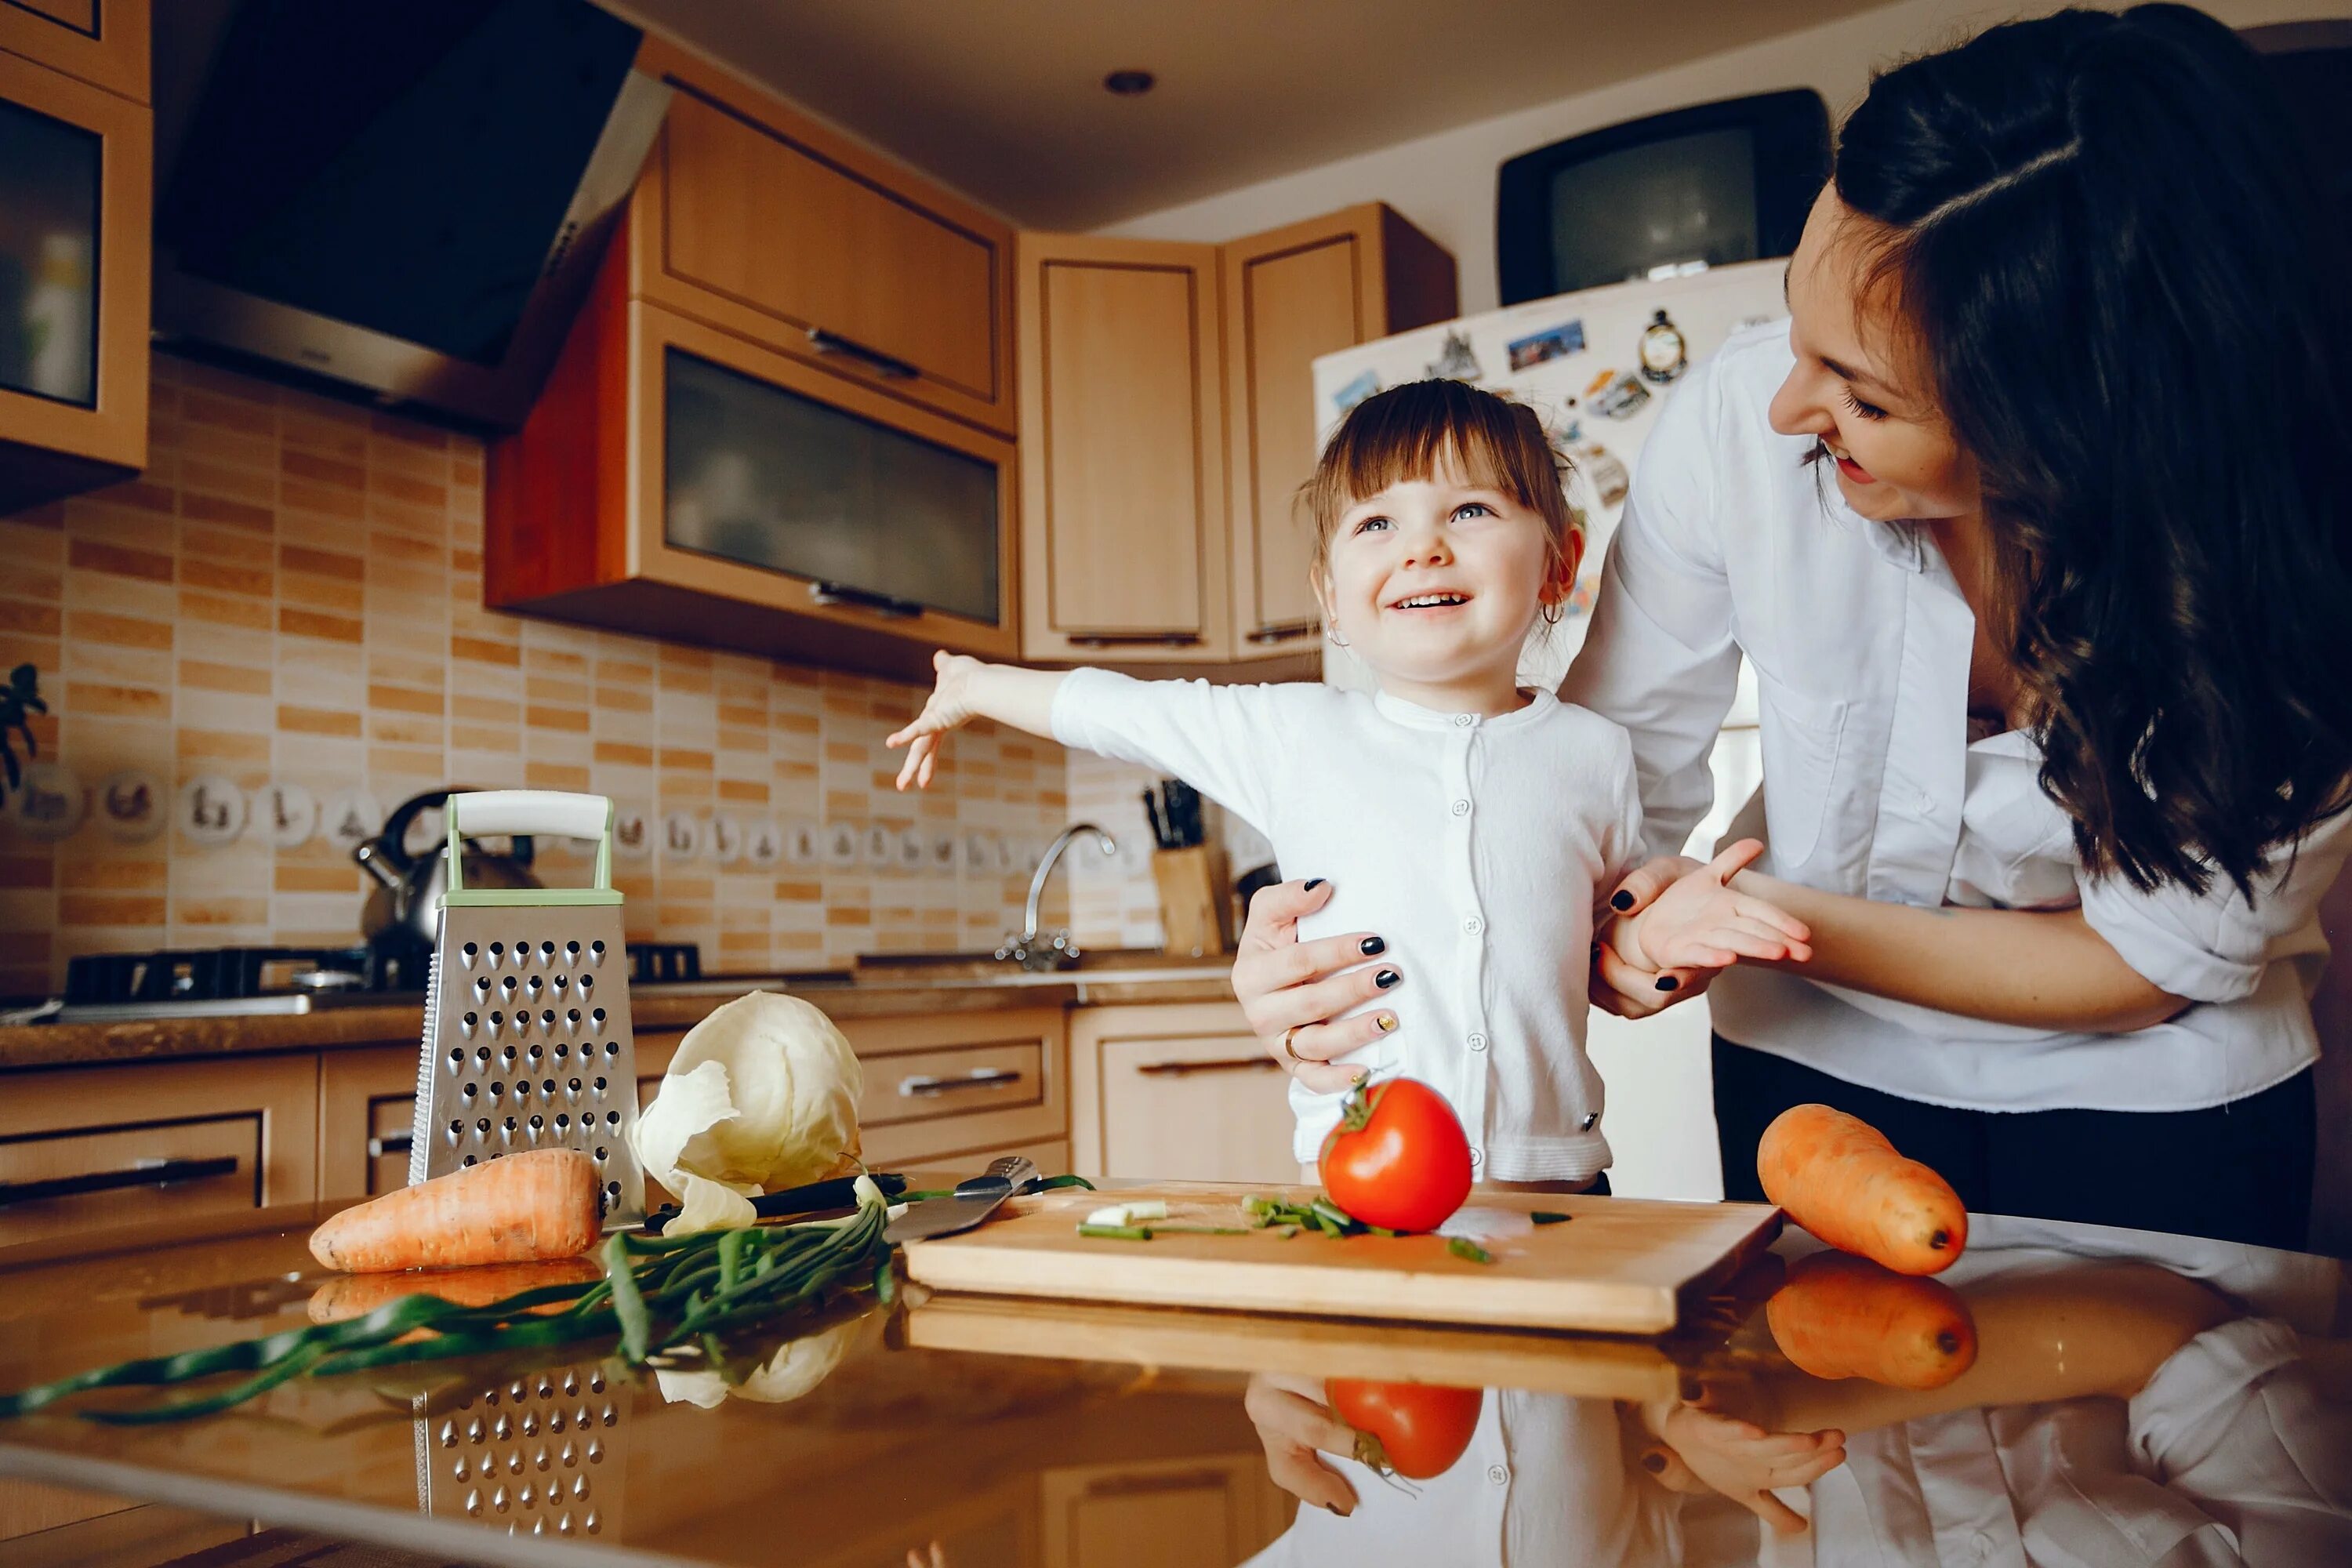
414,1361,628,1535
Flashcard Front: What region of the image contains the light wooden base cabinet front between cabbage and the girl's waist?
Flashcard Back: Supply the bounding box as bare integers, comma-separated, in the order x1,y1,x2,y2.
1070,1001,1298,1182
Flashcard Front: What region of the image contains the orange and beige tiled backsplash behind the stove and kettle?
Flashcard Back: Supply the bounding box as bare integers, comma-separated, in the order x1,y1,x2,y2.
0,355,1077,994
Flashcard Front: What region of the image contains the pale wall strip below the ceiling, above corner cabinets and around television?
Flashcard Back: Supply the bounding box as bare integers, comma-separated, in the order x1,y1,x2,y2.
1103,0,2352,315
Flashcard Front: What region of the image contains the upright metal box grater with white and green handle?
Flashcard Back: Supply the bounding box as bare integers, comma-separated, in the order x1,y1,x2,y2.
409,789,644,1229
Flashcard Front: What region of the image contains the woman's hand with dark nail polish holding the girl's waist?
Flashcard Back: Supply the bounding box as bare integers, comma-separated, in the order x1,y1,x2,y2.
1232,877,1404,1093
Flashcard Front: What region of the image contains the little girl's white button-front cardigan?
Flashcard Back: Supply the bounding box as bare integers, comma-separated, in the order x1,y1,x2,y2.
1054,670,1642,1180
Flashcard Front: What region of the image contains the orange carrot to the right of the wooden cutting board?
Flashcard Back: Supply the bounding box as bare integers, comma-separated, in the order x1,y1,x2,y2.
1757,1105,1969,1274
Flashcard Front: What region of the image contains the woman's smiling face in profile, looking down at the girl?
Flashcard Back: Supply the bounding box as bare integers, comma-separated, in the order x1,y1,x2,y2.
1771,186,1983,522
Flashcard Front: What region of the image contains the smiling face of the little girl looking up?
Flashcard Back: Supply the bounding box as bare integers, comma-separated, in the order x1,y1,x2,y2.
1317,463,1583,713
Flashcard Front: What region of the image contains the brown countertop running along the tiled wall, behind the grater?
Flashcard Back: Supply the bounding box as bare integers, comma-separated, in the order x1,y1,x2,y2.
0,959,1232,1072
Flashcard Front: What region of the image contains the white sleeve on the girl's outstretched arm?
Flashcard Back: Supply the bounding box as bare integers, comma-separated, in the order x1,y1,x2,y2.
1054,670,1298,837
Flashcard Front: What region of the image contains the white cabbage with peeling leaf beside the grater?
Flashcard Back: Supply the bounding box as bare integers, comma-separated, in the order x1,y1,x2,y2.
630,992,866,1236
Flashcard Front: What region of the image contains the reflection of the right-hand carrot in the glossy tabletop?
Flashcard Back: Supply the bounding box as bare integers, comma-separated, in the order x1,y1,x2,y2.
1764,1253,1976,1389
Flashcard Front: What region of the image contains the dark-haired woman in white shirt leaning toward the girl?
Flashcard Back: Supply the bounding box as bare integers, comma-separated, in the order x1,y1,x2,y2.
1235,5,2352,1246
